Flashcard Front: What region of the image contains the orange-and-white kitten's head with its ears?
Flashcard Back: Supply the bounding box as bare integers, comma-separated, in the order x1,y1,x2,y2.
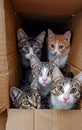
48,29,71,56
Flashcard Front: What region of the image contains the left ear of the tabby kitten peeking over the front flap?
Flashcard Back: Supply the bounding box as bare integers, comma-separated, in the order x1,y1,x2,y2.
10,87,22,101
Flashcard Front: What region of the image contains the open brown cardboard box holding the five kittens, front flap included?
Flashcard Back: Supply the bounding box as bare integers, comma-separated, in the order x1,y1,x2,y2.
0,0,82,130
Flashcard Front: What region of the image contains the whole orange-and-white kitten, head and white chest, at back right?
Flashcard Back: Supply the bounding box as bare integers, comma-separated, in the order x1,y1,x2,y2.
48,29,71,68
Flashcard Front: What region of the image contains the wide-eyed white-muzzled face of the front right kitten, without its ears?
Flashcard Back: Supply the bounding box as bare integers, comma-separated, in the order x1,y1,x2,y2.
51,78,81,105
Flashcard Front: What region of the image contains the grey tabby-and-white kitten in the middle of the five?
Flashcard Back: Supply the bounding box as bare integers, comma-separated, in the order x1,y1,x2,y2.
30,55,59,98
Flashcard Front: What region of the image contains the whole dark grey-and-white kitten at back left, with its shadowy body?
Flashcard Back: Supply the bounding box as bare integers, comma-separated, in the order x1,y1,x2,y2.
17,28,45,89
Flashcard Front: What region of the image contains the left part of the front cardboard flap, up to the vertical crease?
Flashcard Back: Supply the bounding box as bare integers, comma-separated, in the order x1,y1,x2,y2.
6,109,33,130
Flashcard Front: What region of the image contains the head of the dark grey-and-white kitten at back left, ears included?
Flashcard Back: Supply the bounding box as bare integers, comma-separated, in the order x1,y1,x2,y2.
17,29,45,59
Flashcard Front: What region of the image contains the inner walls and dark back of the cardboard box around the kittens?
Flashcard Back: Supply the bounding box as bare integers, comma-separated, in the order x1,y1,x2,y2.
0,0,82,130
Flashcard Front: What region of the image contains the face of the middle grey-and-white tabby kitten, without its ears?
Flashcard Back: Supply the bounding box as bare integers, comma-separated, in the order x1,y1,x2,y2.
33,62,53,86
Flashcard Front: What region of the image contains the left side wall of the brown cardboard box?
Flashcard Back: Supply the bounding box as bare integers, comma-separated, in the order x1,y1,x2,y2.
0,0,21,113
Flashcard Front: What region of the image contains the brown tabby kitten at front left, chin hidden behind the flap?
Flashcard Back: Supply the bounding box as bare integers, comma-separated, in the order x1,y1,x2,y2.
10,87,41,109
